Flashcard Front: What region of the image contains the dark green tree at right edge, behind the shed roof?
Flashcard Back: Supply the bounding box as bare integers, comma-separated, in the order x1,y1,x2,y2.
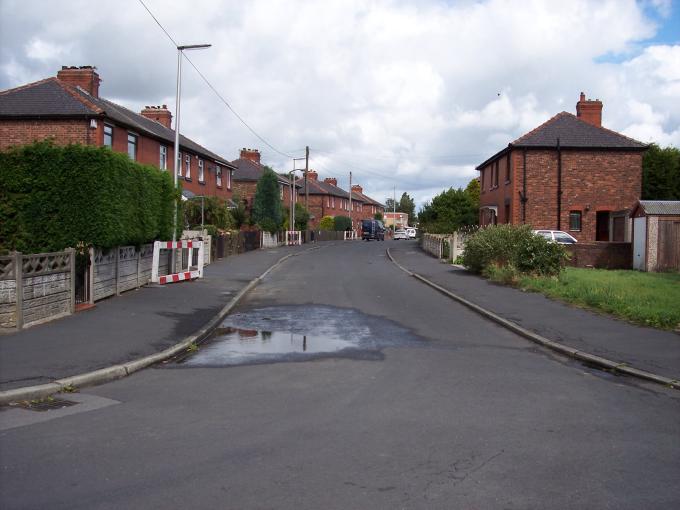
642,144,680,200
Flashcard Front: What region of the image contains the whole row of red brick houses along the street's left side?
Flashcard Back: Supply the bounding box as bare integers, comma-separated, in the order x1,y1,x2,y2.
0,66,385,229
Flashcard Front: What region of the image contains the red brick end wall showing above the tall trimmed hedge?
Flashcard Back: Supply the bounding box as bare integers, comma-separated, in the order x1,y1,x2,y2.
0,119,90,150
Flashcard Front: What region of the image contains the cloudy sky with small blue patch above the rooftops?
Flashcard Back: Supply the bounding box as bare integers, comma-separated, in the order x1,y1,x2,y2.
0,0,680,205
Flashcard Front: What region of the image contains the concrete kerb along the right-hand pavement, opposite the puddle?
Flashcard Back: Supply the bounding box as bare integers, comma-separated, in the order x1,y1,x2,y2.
387,248,680,389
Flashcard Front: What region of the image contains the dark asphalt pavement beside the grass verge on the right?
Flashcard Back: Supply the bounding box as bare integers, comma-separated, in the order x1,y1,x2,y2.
390,242,680,380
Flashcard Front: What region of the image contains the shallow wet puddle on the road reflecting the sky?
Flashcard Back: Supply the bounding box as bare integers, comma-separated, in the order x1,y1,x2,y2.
171,306,424,367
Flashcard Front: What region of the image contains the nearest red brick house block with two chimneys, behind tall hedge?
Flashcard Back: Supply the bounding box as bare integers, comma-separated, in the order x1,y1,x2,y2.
0,66,234,200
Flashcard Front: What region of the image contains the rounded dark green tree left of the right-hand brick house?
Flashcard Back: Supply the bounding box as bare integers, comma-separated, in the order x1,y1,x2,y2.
418,188,479,234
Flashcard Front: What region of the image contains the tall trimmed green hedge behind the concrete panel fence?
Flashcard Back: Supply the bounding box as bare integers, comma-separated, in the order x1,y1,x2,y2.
0,142,181,253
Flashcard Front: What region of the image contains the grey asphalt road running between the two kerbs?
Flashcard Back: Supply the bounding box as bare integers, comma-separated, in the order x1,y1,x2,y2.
0,241,680,509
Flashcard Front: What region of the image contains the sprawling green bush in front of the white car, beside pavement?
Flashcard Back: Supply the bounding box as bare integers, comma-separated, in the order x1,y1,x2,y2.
463,225,567,280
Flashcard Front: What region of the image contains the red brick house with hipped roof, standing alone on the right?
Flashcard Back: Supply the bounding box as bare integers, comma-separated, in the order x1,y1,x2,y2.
477,93,647,241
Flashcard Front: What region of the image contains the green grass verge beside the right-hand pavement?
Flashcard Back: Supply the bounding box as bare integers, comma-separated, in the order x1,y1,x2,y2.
516,267,680,331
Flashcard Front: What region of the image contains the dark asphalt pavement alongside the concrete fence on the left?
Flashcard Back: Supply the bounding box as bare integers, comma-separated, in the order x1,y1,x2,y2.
0,246,310,391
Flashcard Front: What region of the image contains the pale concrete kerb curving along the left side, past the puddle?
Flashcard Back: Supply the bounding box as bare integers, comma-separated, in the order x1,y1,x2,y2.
0,246,321,405
